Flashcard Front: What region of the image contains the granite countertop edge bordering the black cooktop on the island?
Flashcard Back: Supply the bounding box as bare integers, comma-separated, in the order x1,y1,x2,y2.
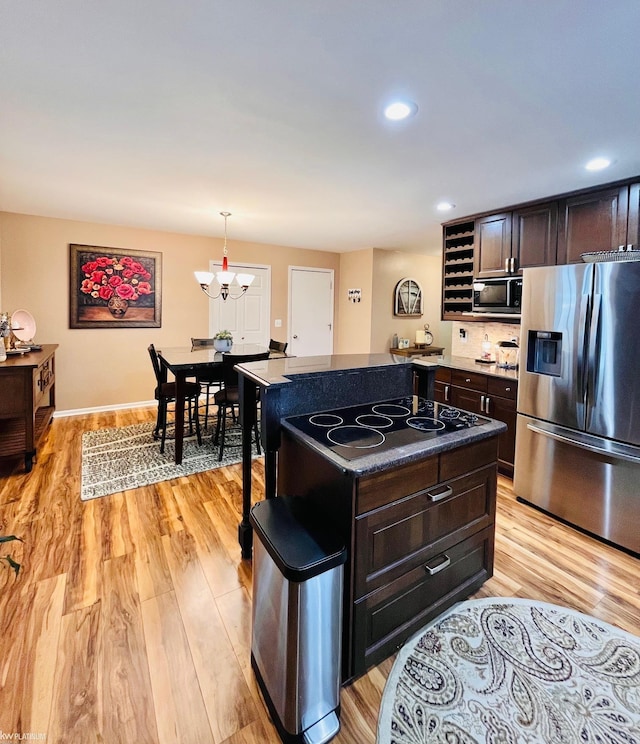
281,412,507,476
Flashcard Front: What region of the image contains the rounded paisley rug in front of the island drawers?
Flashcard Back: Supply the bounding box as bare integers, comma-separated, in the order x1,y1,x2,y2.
377,598,640,744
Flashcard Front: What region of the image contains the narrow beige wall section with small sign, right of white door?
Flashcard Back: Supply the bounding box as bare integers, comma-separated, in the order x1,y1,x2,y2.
334,248,373,354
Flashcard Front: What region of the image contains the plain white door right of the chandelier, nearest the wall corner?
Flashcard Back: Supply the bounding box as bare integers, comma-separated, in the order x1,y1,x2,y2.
287,266,333,357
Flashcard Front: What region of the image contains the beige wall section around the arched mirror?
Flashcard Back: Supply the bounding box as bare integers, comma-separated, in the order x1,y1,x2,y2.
371,248,444,353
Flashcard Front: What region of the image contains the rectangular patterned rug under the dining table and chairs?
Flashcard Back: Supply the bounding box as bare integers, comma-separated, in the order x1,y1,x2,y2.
80,424,257,501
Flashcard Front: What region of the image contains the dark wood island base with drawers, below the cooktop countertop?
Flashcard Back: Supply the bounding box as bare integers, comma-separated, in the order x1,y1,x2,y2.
278,431,498,682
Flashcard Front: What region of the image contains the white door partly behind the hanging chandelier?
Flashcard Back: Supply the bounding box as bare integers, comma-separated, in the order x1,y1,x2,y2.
209,261,271,346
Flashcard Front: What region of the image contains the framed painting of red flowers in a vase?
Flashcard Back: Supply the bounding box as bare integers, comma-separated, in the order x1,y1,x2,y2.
69,243,162,328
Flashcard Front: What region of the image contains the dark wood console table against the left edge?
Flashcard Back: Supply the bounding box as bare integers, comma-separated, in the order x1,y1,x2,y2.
0,344,58,473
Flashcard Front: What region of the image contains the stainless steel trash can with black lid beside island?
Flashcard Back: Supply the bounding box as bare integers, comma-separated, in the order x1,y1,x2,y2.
250,496,347,744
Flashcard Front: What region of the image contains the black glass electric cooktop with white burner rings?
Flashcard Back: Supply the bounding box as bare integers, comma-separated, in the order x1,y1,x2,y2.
287,395,488,460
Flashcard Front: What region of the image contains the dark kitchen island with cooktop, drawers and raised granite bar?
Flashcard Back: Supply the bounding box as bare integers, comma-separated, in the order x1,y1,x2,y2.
239,355,505,683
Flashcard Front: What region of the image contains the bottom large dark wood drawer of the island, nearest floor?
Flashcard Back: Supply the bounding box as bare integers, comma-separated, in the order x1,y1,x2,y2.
353,527,493,676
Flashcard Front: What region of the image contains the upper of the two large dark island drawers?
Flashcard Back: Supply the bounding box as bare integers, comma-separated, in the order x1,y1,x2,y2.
354,465,496,597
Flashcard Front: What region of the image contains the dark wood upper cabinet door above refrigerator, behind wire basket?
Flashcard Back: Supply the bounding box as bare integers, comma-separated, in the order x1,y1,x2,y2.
557,185,629,264
